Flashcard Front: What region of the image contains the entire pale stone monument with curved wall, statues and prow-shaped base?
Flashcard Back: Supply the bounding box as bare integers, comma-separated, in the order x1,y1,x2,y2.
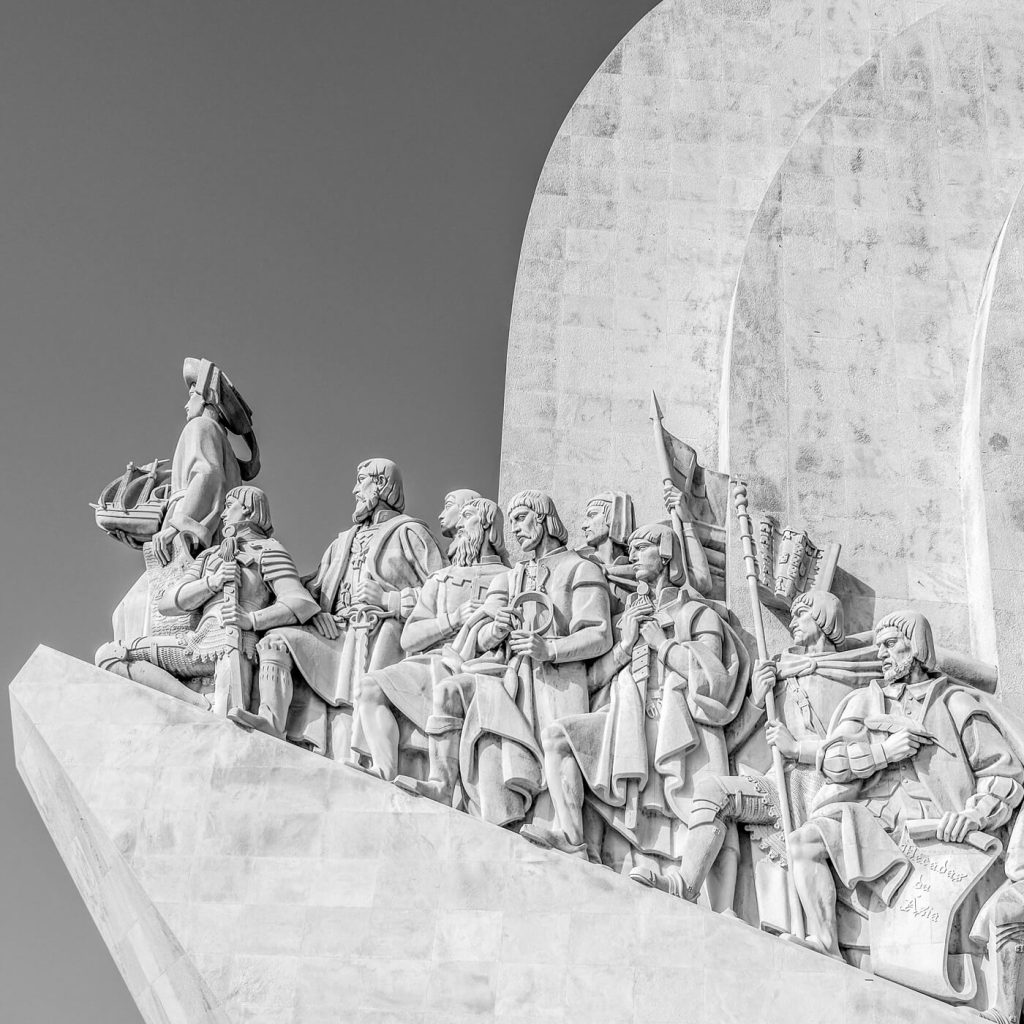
11,0,1024,1024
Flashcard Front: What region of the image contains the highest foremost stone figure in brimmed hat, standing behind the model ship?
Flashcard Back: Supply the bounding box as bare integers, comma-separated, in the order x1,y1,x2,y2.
153,358,260,565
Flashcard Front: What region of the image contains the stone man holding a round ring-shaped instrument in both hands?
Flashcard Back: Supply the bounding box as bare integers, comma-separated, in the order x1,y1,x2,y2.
395,490,611,825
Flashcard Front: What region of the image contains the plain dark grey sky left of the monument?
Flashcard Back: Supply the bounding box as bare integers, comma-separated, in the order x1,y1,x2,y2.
0,0,653,1024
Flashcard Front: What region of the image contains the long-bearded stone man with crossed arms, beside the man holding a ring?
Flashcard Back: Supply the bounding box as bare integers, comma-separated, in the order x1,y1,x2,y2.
357,492,508,780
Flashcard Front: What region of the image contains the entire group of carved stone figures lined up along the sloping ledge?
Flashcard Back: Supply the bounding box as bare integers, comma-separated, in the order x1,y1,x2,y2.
90,359,1024,1021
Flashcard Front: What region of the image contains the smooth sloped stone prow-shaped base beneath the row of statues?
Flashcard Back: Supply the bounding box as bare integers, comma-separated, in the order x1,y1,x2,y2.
10,647,965,1024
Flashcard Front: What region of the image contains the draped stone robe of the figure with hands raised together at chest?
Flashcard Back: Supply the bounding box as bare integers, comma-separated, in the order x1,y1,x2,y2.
560,587,749,860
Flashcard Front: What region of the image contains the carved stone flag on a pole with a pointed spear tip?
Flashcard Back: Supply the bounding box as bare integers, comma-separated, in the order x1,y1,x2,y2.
650,391,729,601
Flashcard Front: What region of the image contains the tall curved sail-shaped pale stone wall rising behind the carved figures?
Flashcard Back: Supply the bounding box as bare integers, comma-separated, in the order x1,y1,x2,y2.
501,0,1024,705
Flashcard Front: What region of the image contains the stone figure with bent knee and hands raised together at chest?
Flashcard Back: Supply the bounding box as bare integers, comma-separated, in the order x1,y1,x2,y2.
523,523,748,891
